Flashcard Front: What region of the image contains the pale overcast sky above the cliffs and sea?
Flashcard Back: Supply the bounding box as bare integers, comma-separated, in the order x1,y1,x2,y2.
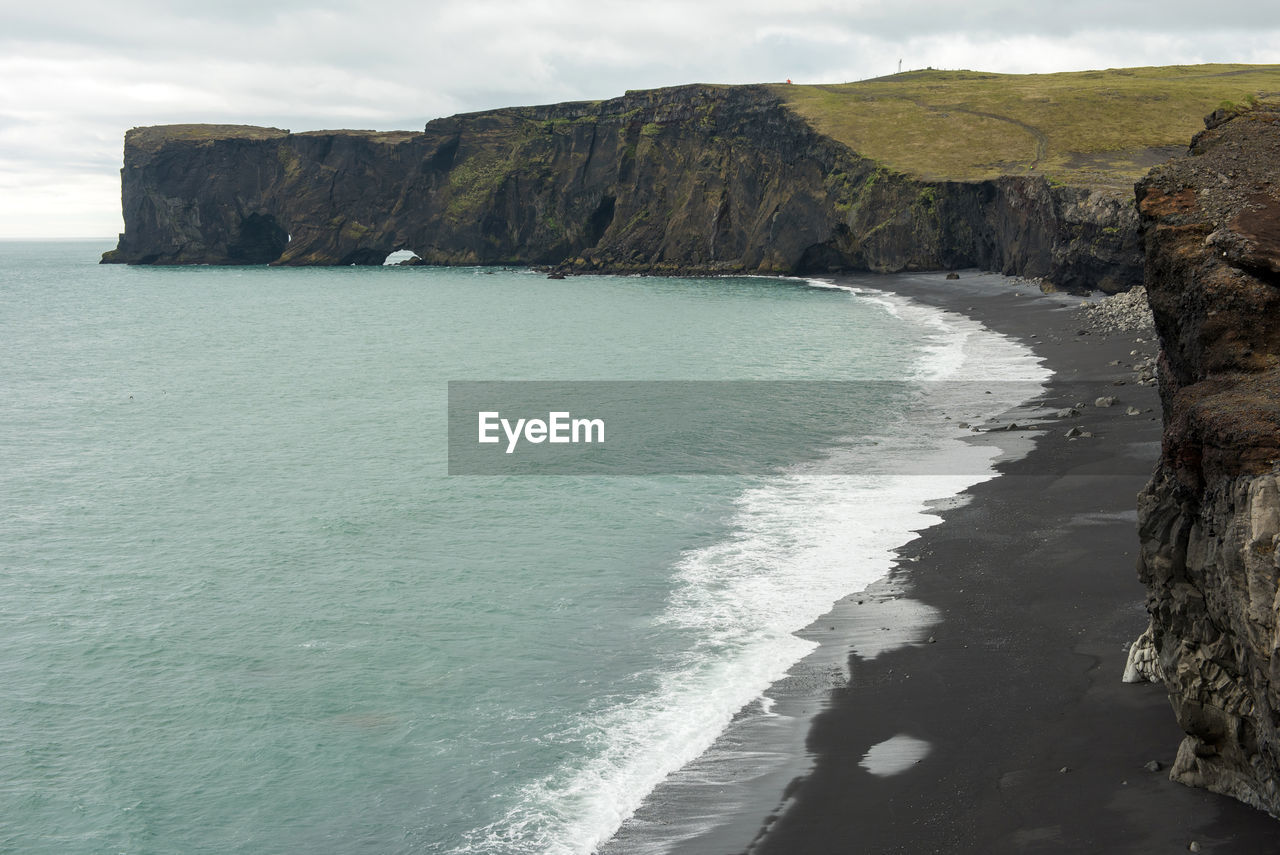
0,0,1280,238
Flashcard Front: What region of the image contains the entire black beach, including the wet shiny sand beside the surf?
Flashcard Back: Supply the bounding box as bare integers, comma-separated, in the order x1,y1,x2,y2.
599,270,1280,855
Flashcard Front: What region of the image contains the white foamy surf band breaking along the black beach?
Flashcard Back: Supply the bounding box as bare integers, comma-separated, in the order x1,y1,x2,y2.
456,277,1048,855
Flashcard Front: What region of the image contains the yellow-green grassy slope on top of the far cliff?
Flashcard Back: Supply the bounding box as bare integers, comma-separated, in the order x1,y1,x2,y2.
773,65,1280,186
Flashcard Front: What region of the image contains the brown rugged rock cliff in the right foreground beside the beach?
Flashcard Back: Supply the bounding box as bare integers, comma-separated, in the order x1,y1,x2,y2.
1130,100,1280,817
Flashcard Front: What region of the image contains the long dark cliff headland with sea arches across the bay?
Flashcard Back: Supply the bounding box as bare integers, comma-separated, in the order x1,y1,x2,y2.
104,86,1140,291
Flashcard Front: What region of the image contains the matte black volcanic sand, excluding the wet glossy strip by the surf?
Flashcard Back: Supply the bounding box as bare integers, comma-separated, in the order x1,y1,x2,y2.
747,274,1280,855
